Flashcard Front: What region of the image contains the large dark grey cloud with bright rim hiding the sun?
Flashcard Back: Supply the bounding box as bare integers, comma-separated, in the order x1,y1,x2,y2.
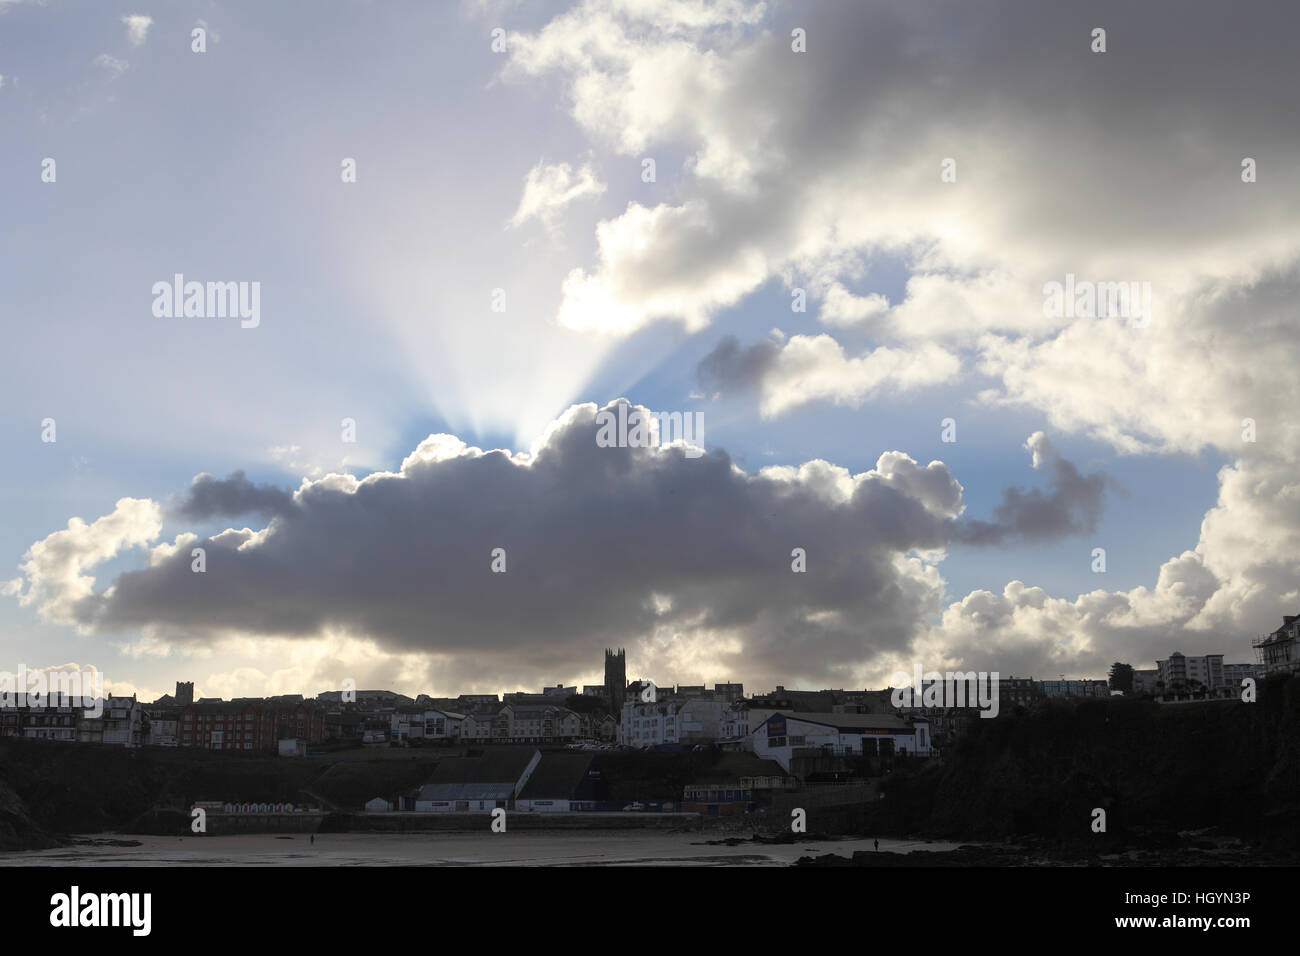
68,405,977,675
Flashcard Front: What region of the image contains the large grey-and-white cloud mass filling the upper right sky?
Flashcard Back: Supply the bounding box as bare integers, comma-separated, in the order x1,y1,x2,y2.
504,0,1300,453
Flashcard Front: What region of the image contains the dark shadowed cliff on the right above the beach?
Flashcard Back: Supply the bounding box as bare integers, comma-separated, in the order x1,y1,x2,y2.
874,678,1300,845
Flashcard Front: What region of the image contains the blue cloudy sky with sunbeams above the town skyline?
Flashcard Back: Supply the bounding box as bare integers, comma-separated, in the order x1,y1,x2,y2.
0,0,1300,698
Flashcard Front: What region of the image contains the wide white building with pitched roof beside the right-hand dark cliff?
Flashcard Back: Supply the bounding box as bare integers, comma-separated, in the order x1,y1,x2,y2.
750,713,931,771
